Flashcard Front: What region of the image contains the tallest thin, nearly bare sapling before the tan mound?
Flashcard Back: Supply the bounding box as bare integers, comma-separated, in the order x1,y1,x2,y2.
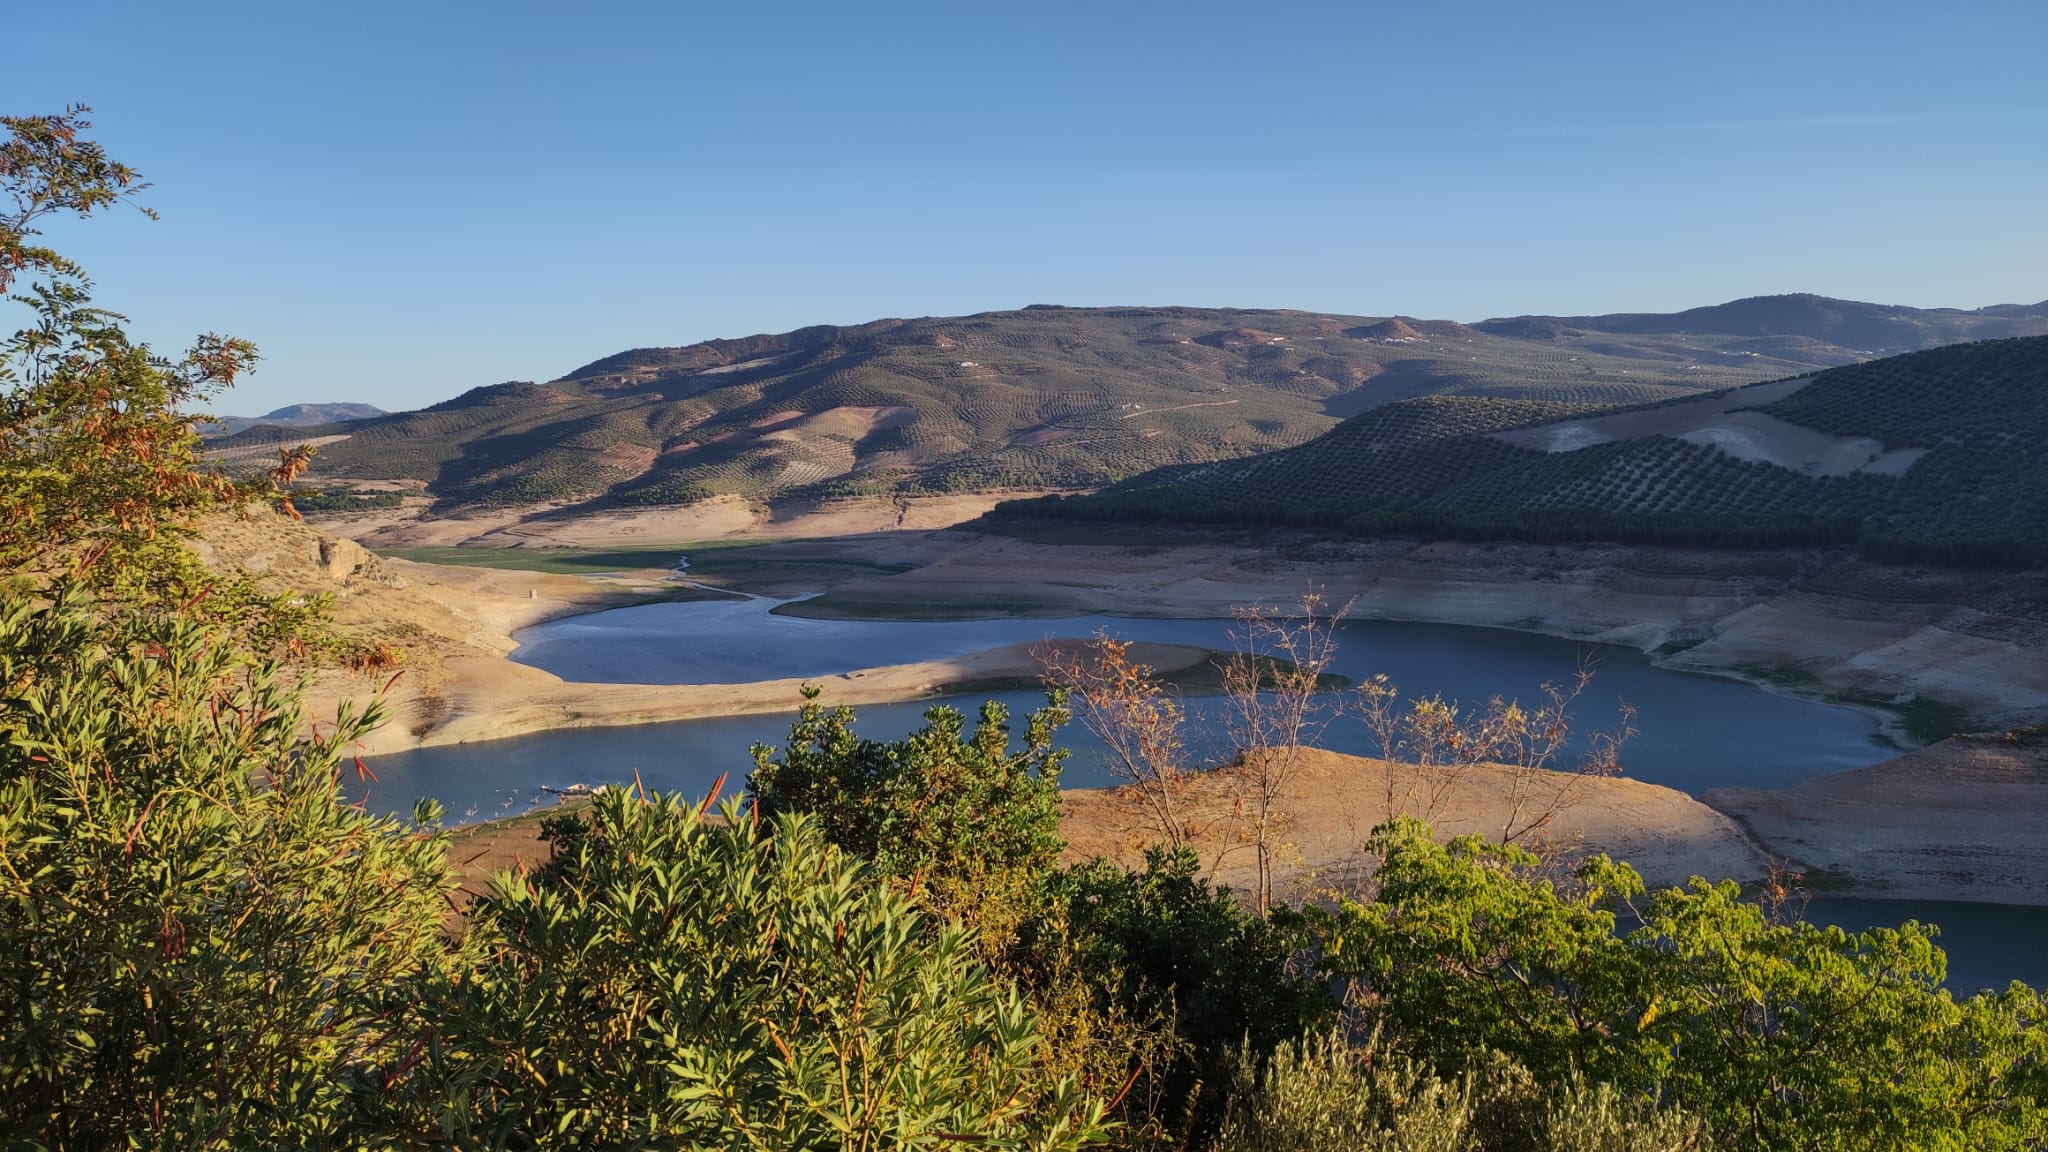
1223,592,1352,912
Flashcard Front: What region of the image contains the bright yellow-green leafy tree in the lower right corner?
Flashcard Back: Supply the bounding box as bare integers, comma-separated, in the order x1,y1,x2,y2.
1323,820,2048,1152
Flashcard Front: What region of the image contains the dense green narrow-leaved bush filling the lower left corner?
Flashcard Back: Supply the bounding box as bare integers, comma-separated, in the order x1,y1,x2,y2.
0,601,446,1148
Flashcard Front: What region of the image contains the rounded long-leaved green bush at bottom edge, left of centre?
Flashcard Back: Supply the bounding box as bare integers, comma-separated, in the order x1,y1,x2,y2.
371,789,1104,1152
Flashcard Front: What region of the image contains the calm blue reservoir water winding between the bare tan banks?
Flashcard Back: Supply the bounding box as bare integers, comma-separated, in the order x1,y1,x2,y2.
356,599,2048,990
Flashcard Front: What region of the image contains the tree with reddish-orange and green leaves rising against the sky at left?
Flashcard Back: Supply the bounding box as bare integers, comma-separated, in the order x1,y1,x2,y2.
0,107,327,654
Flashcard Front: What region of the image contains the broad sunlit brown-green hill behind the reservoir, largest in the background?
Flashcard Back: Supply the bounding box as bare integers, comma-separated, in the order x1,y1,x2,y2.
217,293,2030,506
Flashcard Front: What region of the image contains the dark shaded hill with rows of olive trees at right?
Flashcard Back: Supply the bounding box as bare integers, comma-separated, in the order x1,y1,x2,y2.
997,336,2048,566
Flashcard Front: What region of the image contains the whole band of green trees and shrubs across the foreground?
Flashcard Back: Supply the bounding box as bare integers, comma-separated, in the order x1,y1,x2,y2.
0,115,2048,1152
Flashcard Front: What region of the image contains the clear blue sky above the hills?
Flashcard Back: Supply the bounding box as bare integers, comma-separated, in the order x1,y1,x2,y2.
16,0,2048,412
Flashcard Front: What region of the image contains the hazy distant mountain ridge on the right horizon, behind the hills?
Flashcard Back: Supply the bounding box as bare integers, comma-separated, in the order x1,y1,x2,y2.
1475,293,2048,357
